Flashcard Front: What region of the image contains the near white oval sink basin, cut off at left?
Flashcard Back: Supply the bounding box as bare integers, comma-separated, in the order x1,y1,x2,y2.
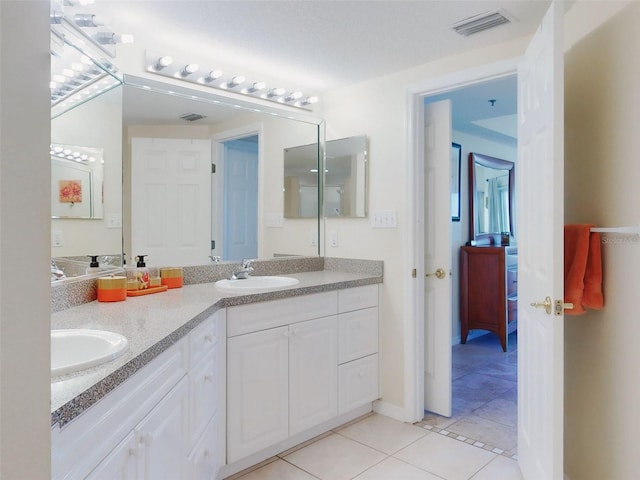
51,329,129,376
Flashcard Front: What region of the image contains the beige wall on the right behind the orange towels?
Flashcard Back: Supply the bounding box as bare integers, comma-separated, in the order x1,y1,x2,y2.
565,2,640,480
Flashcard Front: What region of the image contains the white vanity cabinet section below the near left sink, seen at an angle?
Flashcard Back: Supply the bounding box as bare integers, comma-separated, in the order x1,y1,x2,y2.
52,310,226,480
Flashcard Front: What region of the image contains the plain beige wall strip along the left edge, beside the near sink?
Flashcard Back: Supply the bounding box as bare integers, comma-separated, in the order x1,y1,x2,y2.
0,1,51,480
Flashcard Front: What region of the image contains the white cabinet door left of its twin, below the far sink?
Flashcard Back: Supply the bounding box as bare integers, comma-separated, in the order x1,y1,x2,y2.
227,327,289,463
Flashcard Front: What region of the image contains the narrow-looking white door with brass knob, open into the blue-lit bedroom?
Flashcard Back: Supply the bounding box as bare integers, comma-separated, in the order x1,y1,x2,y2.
424,100,451,417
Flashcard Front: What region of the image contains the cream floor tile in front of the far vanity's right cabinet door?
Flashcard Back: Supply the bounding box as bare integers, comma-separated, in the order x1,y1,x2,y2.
285,434,386,480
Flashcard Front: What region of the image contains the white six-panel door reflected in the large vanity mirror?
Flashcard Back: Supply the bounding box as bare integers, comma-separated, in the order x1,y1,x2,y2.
127,138,211,265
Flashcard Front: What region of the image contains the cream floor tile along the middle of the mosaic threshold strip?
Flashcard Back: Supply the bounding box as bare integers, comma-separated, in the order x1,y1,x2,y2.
394,433,496,480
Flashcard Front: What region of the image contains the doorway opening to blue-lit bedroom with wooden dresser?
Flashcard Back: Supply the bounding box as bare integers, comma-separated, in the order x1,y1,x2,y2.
422,75,518,455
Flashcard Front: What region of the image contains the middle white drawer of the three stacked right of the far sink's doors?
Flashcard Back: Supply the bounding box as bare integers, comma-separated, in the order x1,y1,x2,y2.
338,307,378,364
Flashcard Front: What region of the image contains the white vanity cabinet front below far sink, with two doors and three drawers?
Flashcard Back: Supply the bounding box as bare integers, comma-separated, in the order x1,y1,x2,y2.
227,285,378,473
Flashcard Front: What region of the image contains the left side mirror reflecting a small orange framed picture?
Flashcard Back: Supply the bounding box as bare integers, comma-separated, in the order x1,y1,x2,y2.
51,86,122,263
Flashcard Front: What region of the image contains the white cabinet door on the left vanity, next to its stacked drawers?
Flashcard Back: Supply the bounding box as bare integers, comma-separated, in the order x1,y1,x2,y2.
135,377,189,480
